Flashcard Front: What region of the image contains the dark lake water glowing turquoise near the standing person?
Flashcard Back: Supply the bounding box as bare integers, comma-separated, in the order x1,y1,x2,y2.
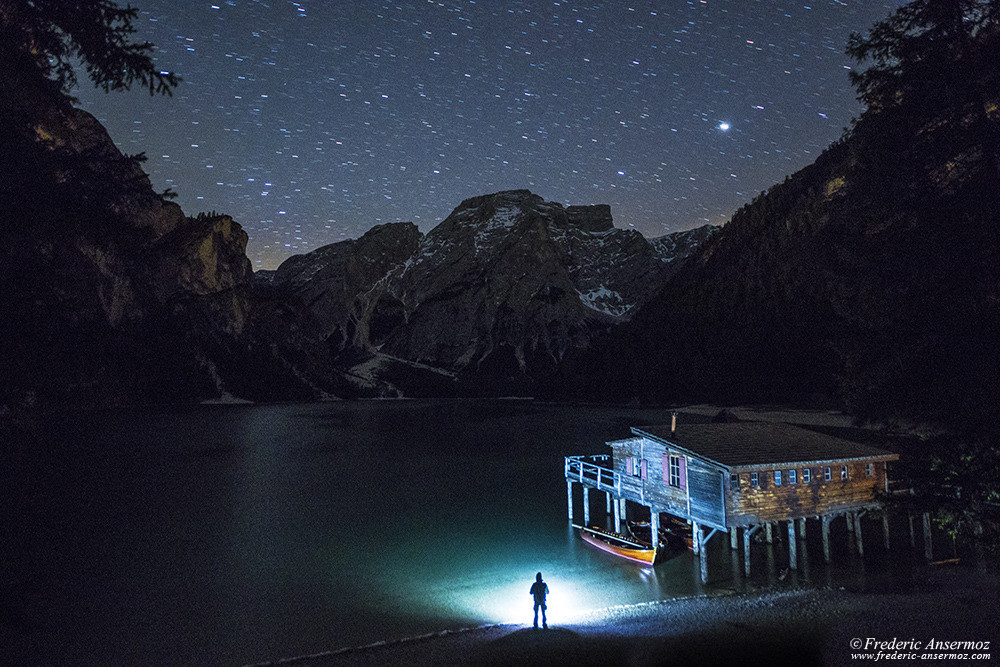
0,401,920,664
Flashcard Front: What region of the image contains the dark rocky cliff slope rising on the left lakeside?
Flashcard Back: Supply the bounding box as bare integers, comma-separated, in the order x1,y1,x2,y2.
0,77,252,406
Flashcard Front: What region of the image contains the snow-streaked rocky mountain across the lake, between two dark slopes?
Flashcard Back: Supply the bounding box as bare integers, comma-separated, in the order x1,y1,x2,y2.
258,190,715,394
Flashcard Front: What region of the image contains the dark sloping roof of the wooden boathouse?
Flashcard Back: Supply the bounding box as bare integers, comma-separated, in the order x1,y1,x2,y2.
632,422,899,468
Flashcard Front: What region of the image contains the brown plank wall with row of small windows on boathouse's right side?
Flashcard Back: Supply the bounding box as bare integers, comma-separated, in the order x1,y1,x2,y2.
726,461,886,526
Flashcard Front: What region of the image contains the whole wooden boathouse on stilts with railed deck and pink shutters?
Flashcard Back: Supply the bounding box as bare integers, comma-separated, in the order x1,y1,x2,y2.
565,415,899,581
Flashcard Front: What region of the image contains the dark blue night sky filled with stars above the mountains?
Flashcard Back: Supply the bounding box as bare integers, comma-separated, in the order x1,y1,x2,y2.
74,0,900,269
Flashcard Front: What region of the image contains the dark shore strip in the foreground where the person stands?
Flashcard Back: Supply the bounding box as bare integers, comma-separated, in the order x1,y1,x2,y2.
258,569,1000,666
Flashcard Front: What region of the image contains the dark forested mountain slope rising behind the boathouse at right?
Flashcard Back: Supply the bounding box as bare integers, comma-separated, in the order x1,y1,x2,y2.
584,15,1000,432
